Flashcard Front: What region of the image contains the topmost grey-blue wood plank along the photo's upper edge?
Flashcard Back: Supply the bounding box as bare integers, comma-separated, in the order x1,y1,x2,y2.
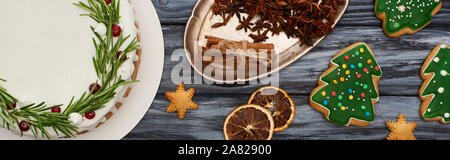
152,0,450,28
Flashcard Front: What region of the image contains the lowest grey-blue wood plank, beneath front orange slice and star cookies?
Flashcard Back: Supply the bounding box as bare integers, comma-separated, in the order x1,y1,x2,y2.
125,94,450,140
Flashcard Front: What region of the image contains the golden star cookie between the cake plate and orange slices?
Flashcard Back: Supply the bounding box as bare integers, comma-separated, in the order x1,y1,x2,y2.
166,83,198,119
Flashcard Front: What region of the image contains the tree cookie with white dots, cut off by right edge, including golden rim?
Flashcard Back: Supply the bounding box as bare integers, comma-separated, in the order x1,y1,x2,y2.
419,44,450,123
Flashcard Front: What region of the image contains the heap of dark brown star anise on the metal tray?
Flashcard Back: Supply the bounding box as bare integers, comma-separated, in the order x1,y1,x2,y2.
211,0,345,45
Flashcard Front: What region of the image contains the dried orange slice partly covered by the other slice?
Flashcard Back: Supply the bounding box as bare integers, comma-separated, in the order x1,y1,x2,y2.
248,86,295,132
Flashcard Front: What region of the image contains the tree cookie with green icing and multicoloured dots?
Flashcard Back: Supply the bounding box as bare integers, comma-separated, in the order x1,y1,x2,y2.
309,42,381,126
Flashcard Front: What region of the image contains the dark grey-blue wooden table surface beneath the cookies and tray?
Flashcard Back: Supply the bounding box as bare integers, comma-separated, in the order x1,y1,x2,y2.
124,0,450,140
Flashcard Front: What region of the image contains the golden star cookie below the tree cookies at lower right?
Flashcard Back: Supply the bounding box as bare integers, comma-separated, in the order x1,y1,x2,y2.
386,114,417,140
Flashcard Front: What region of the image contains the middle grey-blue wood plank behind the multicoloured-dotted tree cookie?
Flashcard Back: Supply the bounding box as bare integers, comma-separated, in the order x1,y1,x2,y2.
158,25,450,96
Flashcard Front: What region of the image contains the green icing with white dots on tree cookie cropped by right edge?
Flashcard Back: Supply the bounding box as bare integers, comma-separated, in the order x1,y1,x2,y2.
421,45,450,122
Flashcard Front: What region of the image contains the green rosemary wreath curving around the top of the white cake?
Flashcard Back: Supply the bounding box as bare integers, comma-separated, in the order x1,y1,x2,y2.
0,0,140,139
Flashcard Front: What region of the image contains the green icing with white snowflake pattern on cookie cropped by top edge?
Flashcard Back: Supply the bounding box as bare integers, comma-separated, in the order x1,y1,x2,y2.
375,0,442,34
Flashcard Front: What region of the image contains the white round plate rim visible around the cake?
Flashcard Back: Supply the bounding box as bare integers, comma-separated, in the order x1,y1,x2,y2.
0,0,164,140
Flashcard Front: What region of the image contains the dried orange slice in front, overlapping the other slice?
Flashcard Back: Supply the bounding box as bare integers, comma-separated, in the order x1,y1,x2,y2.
223,104,274,140
